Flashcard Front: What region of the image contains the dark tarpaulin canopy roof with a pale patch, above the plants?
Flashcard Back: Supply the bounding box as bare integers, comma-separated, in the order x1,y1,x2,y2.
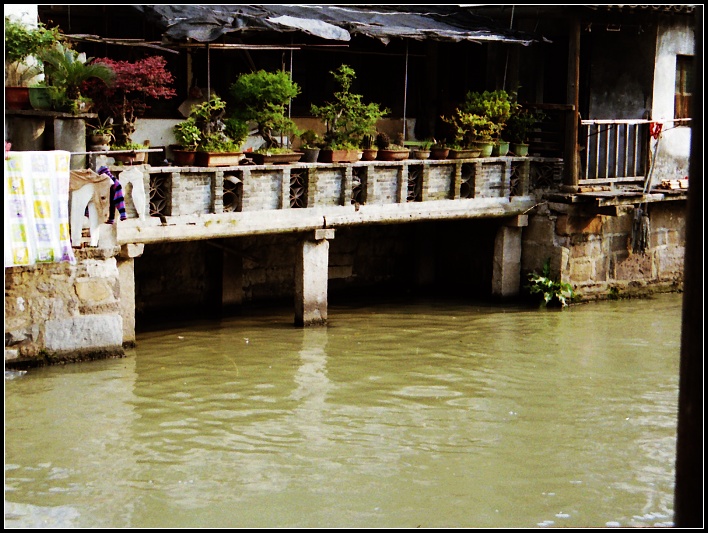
134,5,542,45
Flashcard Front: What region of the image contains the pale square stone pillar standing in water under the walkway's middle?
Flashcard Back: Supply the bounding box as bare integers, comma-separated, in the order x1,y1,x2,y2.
295,229,334,326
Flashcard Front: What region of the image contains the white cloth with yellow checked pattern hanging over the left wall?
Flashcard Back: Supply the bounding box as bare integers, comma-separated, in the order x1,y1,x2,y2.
5,150,76,267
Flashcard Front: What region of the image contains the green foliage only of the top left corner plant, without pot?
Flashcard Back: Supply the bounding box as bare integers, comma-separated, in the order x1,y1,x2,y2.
5,16,63,86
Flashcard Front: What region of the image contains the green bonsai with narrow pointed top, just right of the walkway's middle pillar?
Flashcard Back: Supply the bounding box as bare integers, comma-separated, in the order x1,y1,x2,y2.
311,65,390,148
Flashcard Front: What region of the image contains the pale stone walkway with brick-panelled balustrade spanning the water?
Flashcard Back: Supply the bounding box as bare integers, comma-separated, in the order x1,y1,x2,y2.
105,157,562,245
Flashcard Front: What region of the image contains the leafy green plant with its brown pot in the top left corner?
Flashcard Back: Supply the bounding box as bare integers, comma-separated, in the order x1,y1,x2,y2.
5,16,62,109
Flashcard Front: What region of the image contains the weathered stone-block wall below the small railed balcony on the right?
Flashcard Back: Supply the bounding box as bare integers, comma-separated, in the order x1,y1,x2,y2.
521,201,686,299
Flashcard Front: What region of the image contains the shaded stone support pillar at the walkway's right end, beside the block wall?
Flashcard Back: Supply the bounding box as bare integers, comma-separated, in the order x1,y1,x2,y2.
492,215,529,298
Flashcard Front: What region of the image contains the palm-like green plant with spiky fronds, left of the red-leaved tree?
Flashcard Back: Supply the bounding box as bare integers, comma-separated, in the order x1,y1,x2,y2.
39,42,115,113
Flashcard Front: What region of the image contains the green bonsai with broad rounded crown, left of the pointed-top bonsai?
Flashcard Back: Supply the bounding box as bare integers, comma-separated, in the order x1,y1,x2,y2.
229,70,300,152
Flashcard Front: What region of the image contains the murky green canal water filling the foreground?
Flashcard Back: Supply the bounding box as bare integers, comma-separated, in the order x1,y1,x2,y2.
5,294,681,528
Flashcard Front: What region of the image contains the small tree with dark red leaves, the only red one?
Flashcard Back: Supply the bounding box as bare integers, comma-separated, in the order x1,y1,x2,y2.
84,56,177,148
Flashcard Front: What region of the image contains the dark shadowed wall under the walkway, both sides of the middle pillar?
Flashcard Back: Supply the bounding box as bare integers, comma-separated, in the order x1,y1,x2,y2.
135,220,500,329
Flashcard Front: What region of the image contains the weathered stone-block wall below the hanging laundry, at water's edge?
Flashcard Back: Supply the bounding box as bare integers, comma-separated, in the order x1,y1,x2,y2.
5,248,127,363
